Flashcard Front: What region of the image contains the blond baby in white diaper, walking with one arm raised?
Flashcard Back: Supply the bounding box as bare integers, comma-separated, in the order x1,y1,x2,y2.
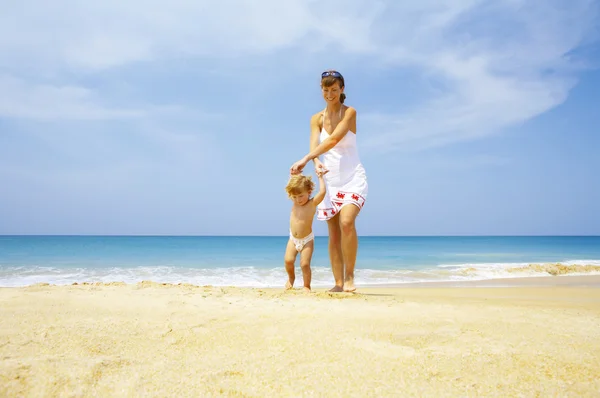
284,171,327,292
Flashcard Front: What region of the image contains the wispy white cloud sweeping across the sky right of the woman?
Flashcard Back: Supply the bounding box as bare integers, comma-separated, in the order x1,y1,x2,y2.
363,0,598,151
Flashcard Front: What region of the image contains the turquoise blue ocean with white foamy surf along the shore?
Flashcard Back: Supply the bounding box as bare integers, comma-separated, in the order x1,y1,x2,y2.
0,235,600,287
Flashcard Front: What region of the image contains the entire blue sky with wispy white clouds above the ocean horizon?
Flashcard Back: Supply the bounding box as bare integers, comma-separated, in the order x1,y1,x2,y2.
0,0,600,235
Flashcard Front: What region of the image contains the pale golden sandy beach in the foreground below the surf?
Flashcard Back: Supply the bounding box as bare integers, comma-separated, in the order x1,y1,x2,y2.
0,276,600,397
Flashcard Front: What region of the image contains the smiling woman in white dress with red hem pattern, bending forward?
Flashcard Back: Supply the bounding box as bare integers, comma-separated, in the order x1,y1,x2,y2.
290,70,368,292
